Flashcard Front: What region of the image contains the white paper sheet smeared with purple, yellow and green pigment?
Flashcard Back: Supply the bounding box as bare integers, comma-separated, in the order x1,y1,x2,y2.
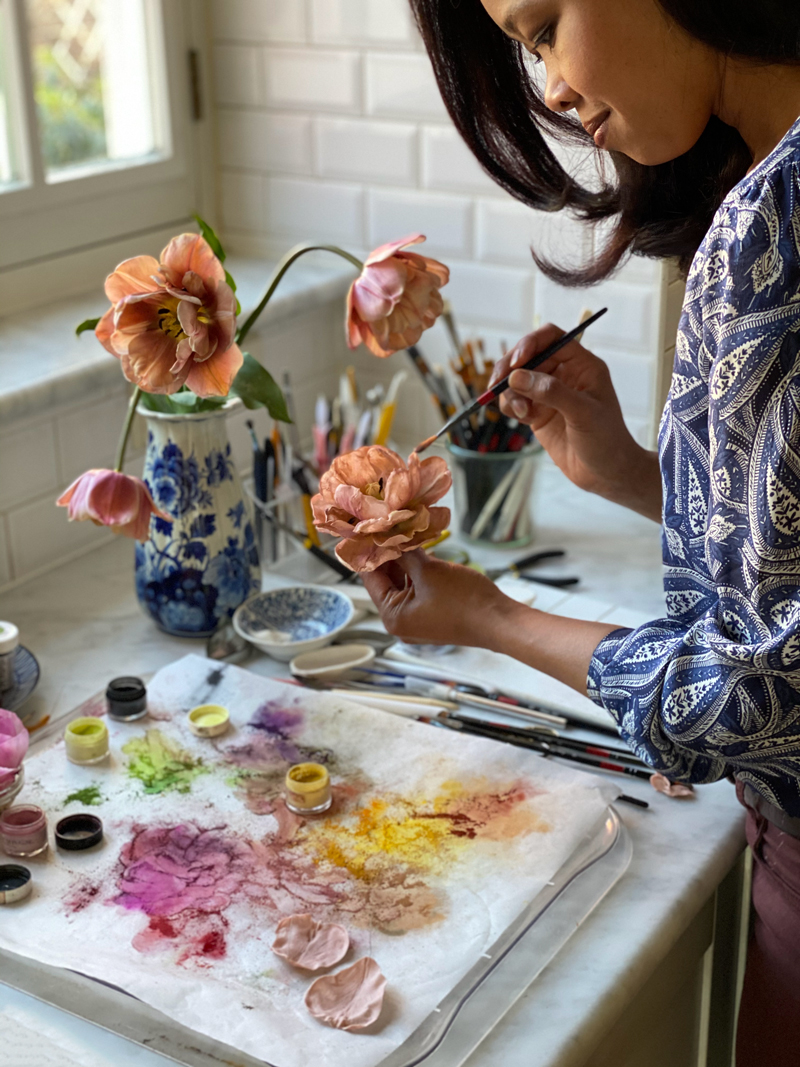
0,655,618,1067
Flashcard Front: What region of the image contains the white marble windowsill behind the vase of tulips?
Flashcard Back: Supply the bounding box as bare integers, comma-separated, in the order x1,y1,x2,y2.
0,253,354,427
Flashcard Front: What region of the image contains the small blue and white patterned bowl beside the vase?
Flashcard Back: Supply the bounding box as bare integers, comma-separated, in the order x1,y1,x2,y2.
234,586,355,660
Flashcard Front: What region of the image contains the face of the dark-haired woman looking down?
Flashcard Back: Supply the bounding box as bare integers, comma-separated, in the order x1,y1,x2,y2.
481,0,720,166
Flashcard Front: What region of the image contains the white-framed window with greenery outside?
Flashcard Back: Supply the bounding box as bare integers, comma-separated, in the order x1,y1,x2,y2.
0,0,210,315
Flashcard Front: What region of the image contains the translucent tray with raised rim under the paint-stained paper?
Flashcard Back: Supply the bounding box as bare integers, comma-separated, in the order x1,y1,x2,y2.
0,807,633,1067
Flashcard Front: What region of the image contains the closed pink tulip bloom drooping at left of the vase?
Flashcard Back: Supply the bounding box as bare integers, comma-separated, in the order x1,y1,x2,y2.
55,471,172,541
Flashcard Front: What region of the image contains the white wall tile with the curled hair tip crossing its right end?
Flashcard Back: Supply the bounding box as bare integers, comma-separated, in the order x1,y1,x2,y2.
477,198,592,268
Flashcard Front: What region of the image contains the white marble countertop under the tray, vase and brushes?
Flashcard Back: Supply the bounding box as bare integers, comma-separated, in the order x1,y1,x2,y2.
0,465,745,1067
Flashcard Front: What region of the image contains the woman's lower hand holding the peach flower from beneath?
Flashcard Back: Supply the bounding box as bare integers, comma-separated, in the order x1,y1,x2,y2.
362,548,509,648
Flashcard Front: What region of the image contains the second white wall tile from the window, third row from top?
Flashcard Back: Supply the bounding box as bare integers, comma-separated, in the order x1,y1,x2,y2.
316,118,417,185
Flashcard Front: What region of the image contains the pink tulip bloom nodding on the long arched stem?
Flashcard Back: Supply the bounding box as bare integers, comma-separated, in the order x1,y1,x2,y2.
346,234,450,359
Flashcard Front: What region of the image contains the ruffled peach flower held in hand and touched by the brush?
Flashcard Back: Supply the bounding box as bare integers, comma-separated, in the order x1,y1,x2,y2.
311,445,452,573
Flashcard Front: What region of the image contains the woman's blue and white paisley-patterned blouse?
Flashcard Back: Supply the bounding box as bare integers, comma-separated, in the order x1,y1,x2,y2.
588,122,800,816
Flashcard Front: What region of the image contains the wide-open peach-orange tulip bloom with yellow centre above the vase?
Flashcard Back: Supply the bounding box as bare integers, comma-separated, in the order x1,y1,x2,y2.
95,234,243,397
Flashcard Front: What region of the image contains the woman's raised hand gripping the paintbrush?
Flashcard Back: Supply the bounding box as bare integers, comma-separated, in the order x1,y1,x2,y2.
491,323,661,522
